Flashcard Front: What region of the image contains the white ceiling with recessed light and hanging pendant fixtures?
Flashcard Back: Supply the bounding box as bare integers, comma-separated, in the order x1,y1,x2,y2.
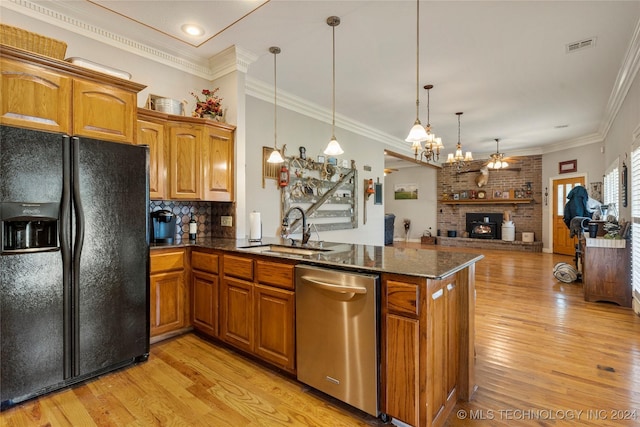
8,0,640,165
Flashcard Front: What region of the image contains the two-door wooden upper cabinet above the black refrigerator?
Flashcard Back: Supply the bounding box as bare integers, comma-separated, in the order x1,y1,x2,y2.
0,46,145,144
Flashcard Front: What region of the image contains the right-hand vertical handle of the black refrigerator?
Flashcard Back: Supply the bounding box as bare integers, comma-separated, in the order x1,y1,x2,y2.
71,136,85,376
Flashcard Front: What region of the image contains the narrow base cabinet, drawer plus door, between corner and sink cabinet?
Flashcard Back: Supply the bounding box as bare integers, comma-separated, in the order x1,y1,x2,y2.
191,250,220,337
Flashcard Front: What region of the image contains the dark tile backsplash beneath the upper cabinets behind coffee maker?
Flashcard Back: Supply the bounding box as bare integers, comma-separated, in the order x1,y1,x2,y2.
149,200,236,239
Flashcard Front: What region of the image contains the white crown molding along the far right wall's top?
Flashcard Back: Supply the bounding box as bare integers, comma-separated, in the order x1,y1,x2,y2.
599,20,640,139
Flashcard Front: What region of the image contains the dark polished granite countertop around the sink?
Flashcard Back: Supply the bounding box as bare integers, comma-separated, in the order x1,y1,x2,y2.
150,238,484,279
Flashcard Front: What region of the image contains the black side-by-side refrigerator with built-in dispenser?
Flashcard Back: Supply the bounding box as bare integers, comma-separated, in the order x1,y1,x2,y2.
0,126,149,409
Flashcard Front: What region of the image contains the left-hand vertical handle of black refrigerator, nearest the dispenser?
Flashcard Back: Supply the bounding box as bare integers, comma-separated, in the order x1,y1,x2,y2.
58,135,73,380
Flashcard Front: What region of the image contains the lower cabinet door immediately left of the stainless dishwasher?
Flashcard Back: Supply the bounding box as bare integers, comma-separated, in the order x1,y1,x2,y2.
254,285,295,371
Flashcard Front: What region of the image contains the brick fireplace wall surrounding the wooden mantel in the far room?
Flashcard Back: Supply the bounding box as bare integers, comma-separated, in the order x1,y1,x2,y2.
437,155,543,241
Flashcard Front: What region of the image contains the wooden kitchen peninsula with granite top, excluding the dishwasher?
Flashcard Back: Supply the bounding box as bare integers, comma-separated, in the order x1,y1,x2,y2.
151,238,483,426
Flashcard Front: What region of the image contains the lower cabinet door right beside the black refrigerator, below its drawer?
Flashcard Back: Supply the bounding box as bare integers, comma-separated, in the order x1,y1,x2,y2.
150,271,184,337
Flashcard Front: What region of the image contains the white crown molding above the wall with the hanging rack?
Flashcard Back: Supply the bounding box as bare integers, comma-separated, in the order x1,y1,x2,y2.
245,77,413,155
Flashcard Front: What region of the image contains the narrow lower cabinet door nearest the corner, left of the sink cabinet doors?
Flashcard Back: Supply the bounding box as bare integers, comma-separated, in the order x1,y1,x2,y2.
191,270,219,337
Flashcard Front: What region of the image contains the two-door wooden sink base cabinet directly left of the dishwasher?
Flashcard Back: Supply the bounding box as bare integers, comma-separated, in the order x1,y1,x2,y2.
220,254,295,373
